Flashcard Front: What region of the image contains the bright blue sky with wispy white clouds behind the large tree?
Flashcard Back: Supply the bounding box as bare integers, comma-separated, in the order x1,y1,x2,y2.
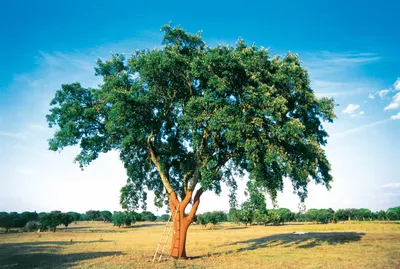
0,0,400,212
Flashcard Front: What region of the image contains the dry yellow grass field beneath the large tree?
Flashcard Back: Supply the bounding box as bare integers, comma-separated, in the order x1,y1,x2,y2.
0,222,400,269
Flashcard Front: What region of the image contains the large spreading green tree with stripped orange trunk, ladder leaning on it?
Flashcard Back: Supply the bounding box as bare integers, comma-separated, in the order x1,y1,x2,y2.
47,25,335,257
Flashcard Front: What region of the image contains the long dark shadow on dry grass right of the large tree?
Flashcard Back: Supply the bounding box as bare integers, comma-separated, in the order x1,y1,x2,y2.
219,232,365,253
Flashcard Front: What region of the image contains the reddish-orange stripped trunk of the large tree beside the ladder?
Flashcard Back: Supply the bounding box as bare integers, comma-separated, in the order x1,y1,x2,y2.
169,189,202,259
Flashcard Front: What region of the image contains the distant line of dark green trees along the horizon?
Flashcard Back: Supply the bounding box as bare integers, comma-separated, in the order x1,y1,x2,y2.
0,204,400,232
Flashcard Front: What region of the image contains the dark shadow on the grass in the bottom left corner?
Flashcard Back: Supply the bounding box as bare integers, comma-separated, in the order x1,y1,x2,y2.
0,240,124,269
